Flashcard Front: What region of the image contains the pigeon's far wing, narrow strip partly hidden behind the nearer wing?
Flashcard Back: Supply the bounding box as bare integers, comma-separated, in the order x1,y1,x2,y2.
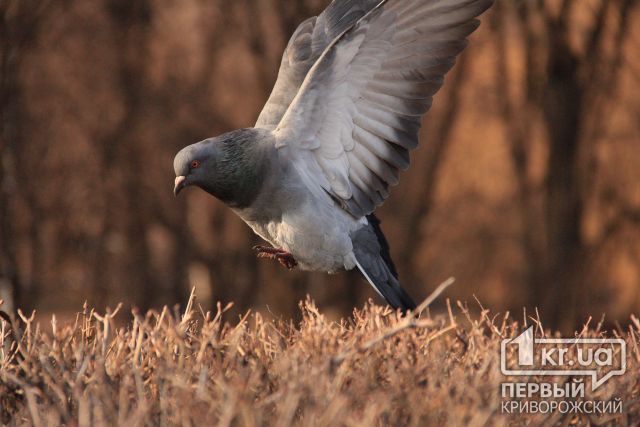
255,0,381,128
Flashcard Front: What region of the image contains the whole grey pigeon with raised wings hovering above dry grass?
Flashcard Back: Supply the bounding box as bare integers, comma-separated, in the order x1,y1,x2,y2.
173,0,493,312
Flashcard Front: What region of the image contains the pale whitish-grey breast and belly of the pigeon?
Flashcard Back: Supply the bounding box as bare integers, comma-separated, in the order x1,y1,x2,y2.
234,142,367,272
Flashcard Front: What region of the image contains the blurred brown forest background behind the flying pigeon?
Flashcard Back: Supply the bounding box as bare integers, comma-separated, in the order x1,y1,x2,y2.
0,0,640,332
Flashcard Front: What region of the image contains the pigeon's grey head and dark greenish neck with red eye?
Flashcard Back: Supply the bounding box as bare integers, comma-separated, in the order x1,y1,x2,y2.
173,129,265,207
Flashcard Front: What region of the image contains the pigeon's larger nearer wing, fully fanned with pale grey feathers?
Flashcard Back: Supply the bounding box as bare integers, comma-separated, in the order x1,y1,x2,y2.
274,0,492,218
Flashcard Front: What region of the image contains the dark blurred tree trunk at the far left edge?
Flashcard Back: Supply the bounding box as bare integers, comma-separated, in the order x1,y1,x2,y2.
0,0,67,307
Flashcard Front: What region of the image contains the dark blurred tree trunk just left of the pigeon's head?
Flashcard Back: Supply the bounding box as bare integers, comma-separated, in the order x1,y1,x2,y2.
105,0,158,310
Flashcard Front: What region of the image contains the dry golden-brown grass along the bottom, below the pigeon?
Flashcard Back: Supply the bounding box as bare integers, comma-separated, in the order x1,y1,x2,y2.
0,286,640,426
